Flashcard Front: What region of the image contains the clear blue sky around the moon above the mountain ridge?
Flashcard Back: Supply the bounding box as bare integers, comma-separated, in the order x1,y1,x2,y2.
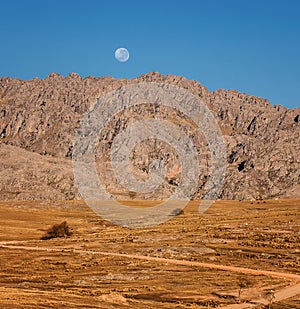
0,0,300,108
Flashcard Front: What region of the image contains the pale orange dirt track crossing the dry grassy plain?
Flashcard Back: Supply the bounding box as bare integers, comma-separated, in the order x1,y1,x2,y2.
0,241,300,309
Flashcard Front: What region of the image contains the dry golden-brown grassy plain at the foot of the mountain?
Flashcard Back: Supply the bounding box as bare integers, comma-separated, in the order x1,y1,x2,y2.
0,200,300,309
